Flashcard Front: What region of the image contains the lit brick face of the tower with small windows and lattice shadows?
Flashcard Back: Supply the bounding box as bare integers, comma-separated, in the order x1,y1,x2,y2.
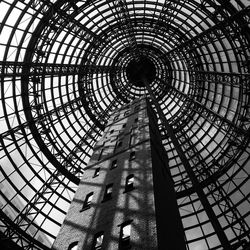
53,99,186,250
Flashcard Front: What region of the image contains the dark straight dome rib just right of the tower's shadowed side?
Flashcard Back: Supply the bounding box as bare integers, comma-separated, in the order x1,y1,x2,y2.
143,77,231,250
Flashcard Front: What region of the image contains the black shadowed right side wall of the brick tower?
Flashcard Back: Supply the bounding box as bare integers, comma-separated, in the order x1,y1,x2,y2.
147,102,186,250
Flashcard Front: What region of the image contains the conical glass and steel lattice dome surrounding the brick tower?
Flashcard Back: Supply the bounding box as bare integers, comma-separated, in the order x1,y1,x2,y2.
0,0,250,250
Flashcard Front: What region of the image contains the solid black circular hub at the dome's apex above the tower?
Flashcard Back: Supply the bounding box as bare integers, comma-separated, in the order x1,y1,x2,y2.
126,57,156,87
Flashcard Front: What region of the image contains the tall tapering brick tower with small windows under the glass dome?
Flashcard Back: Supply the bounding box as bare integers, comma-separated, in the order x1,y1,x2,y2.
53,98,186,250
